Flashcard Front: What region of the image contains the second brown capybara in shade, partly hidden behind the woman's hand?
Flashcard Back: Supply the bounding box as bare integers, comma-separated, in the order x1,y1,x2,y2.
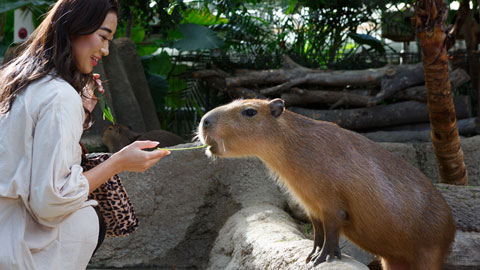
102,125,185,153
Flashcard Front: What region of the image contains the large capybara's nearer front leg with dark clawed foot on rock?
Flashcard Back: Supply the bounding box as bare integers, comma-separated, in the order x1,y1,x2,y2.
310,215,342,266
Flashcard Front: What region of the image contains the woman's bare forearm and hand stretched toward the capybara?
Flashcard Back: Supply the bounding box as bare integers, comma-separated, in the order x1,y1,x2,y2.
83,141,170,193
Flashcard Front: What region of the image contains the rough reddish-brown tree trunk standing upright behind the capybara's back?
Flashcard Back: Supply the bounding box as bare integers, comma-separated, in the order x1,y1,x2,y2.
415,0,468,185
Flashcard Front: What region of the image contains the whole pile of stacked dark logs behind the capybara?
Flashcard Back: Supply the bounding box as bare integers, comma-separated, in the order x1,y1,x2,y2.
193,57,477,141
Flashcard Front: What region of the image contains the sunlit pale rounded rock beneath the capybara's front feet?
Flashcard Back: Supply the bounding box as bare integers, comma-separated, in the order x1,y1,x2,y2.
207,204,368,270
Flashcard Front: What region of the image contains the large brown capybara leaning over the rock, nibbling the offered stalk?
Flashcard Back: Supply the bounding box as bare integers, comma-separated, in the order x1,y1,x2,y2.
199,99,455,270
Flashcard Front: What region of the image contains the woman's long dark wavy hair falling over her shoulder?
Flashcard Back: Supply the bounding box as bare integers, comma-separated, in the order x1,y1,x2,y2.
0,0,118,127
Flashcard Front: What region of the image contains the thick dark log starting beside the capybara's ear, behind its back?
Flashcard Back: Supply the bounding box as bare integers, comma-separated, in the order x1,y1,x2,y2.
289,96,472,130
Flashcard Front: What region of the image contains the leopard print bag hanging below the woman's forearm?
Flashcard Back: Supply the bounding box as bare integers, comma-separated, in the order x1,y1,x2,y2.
82,154,138,238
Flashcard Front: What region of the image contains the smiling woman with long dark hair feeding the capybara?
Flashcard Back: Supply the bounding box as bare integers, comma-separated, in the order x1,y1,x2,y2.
0,0,169,269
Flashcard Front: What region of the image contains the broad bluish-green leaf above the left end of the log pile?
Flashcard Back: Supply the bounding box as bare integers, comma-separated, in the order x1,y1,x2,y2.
173,24,224,51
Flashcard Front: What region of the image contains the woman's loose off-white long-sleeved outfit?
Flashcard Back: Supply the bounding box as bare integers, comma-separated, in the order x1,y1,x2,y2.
0,76,98,270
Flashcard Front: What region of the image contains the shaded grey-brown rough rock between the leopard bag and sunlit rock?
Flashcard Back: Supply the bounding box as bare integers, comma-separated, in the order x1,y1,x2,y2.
91,144,286,269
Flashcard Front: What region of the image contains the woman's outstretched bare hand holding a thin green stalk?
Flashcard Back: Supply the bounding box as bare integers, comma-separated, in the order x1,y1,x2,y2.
110,141,170,172
